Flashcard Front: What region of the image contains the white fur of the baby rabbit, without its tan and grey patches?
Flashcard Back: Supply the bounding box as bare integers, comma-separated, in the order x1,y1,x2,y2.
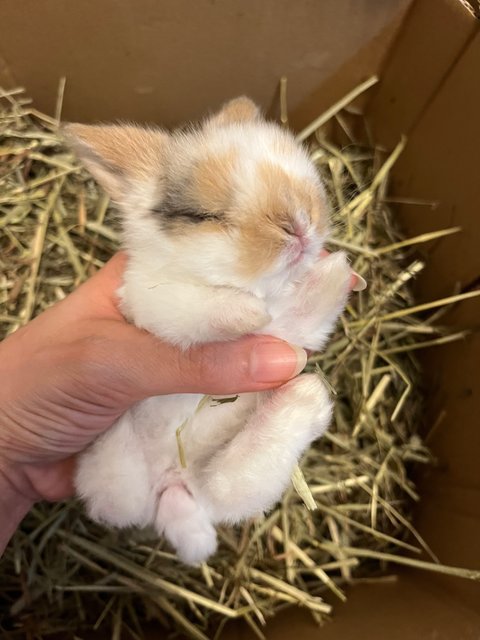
76,104,351,563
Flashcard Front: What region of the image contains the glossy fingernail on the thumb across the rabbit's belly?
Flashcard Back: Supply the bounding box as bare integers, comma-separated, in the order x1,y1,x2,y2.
250,341,307,382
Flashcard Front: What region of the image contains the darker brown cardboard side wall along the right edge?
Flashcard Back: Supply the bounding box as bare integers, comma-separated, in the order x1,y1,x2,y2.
372,23,480,611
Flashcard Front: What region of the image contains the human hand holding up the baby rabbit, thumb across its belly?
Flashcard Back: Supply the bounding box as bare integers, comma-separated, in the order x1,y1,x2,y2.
0,254,306,548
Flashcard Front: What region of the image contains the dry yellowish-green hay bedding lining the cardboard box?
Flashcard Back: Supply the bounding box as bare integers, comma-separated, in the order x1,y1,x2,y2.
0,79,479,640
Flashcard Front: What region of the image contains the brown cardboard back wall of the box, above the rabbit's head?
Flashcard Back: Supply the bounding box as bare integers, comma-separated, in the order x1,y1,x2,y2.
0,0,411,125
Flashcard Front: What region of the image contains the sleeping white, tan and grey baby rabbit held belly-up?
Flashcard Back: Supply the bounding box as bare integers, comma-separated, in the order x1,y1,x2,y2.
65,97,362,563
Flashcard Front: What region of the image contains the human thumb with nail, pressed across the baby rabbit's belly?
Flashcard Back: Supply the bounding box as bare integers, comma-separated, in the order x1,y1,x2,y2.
109,325,307,402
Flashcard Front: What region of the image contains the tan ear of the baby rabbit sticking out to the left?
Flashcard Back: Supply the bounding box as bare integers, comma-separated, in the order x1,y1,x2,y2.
63,124,169,202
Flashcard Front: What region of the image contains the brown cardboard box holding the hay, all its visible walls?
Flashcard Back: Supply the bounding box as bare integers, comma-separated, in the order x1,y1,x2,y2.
0,0,480,640
